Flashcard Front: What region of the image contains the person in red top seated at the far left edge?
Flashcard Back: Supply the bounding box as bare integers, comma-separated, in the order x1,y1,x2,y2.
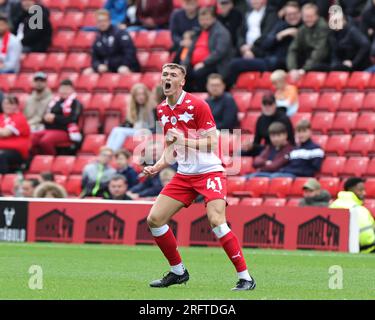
0,95,30,174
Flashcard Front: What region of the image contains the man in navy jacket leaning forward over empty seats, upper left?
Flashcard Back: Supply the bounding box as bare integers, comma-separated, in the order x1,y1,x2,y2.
84,9,140,74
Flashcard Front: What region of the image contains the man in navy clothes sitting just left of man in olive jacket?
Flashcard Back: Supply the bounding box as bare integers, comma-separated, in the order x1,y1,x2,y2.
227,1,301,86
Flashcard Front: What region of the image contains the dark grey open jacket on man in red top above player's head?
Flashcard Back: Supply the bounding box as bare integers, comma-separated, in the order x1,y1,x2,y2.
186,21,234,77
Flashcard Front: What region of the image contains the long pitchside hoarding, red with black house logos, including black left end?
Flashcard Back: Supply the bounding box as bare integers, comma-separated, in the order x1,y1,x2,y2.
0,198,358,252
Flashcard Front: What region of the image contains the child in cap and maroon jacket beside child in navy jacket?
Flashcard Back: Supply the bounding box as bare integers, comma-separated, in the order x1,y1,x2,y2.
248,122,293,178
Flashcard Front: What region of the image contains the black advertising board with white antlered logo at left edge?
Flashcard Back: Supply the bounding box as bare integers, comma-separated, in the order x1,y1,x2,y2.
0,200,28,242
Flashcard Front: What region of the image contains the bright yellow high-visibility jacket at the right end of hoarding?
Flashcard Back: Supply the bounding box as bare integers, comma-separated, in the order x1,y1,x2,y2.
329,191,375,253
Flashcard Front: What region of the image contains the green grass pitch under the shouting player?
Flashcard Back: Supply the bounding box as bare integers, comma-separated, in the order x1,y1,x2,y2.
0,243,375,300
